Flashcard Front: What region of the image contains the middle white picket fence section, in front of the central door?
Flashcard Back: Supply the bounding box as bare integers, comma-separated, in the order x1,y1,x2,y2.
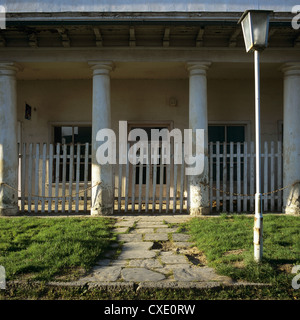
114,144,189,213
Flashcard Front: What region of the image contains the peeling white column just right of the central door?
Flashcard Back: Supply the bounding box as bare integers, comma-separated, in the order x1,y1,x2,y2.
187,62,210,215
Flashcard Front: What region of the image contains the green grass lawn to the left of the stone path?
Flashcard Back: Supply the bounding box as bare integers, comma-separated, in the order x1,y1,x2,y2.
0,217,116,281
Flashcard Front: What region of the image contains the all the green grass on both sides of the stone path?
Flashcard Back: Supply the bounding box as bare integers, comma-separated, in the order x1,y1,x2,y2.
0,214,300,300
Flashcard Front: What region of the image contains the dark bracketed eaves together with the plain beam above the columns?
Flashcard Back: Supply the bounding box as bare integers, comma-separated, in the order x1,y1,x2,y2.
0,14,300,80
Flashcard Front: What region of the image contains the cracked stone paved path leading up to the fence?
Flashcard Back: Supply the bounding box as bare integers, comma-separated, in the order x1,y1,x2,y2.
81,215,232,287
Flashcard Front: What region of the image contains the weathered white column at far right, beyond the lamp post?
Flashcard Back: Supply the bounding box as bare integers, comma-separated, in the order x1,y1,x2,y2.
282,63,300,214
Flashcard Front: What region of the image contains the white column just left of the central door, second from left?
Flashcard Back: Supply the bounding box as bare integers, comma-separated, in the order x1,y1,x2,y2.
89,61,113,215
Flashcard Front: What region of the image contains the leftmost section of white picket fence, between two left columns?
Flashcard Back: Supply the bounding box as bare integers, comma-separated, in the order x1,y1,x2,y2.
19,143,91,213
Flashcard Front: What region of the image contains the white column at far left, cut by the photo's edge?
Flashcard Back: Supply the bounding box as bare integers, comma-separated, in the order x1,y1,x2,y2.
0,62,18,215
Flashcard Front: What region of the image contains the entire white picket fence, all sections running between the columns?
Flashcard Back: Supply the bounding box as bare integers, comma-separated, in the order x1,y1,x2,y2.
19,142,282,213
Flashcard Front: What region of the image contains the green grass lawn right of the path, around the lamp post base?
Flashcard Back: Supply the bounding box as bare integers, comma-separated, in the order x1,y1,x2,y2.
183,214,300,291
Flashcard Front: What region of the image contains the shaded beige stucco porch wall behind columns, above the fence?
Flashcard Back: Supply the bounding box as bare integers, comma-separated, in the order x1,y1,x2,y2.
17,79,283,142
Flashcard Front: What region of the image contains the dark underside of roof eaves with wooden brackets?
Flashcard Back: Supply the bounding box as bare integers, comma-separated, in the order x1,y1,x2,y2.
0,15,300,48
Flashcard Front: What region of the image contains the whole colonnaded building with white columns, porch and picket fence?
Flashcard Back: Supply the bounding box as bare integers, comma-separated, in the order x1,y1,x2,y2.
0,0,300,215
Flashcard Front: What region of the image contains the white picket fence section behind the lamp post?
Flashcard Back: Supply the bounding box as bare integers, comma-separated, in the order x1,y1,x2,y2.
209,141,283,212
